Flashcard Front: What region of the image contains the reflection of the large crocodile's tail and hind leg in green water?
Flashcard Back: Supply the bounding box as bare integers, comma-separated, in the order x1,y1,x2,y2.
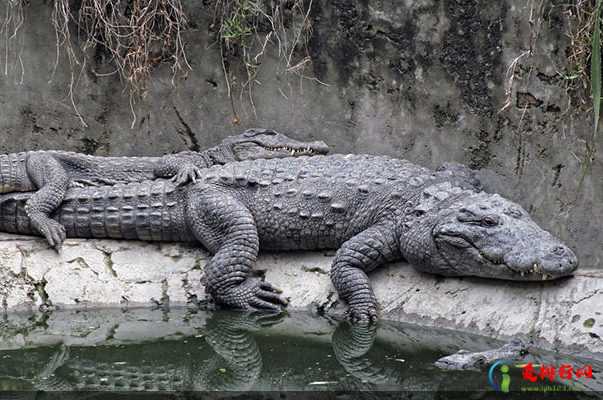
2,312,282,391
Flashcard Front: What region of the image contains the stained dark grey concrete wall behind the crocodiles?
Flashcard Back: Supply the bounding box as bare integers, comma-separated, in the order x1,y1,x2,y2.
0,0,603,269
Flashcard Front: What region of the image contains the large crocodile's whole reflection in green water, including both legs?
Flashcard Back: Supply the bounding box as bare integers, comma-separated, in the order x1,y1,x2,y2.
0,312,410,391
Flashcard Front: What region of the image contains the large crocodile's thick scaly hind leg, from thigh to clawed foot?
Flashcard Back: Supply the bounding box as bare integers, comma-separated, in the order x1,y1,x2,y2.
186,187,287,310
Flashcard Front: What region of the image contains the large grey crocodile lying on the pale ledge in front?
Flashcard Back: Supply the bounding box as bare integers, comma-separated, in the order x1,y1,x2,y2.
0,155,578,324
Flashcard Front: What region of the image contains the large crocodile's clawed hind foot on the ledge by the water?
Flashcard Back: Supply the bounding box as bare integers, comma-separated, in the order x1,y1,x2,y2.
217,278,288,311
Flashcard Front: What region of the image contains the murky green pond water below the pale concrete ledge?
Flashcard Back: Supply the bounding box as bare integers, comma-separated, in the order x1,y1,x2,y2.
0,308,603,398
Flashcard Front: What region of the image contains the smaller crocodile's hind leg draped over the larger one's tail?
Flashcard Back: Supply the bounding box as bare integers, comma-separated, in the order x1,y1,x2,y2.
25,154,69,251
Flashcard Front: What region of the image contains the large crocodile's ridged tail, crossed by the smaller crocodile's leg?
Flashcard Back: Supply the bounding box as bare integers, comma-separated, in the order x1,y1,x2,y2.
0,180,196,241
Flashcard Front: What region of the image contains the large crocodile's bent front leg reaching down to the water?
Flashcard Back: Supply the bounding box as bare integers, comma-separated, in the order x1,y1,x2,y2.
331,226,400,324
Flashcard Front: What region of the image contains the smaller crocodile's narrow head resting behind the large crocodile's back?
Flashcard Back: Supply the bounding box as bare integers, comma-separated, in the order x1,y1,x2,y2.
221,129,329,161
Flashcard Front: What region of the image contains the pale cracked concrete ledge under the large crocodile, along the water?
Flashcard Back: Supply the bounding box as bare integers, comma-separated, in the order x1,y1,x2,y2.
0,234,603,358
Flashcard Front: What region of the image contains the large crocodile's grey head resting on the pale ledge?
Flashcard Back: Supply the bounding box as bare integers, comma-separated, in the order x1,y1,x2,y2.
410,192,578,281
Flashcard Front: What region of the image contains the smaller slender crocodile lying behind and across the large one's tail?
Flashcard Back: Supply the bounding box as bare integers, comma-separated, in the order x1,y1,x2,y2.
0,129,329,251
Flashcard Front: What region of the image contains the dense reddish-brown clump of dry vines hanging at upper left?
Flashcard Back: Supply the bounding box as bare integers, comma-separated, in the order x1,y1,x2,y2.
82,0,190,124
